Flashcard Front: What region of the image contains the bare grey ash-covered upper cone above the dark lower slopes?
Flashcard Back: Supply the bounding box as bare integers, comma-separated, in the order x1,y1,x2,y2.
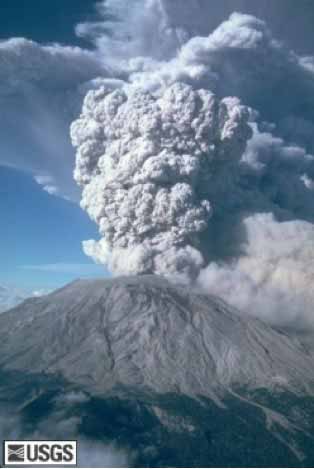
0,276,314,399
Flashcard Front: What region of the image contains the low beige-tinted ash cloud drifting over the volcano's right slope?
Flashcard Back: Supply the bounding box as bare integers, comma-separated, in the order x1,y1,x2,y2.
199,214,314,331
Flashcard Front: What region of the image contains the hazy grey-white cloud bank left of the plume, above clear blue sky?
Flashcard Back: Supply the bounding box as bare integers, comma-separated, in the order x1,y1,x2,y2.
0,38,105,199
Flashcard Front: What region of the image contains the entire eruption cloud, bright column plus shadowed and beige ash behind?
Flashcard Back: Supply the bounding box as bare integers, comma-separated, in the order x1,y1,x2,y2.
71,0,314,328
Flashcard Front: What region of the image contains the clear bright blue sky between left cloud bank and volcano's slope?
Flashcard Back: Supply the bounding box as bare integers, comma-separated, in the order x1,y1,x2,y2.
0,167,105,289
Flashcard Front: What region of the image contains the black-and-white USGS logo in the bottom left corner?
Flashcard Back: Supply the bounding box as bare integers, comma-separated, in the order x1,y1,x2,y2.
3,441,77,467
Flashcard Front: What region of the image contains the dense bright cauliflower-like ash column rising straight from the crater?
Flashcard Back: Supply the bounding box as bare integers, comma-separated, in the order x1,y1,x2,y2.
72,83,251,278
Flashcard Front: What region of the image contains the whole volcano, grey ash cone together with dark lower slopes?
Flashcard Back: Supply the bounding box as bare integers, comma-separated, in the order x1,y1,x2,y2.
0,276,314,467
